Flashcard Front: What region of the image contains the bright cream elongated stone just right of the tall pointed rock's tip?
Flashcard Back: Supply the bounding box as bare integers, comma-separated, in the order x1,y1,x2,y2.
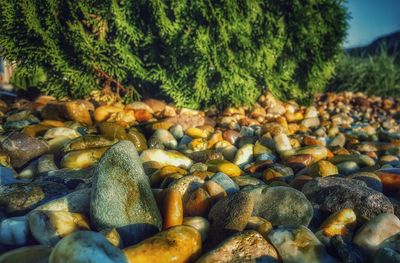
140,149,193,170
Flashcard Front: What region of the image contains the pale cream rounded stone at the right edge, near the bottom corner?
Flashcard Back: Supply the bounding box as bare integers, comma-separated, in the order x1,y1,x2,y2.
353,213,400,254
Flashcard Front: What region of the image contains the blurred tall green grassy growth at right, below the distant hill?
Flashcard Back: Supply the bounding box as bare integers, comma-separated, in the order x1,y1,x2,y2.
328,50,400,96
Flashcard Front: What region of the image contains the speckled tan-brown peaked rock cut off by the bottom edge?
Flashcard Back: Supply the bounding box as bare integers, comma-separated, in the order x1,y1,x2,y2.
196,230,279,263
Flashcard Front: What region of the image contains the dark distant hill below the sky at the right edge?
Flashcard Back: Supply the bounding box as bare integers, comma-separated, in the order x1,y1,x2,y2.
345,31,400,63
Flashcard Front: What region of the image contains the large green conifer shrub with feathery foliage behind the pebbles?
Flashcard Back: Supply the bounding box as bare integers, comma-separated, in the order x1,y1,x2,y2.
0,0,346,108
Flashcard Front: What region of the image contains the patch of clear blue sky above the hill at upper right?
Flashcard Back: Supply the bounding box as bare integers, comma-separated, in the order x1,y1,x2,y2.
344,0,400,47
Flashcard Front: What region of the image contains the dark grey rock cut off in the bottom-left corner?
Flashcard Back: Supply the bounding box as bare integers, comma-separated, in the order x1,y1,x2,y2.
0,245,51,263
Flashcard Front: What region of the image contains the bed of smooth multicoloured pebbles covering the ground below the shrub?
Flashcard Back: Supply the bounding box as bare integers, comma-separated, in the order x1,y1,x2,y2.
0,92,400,263
